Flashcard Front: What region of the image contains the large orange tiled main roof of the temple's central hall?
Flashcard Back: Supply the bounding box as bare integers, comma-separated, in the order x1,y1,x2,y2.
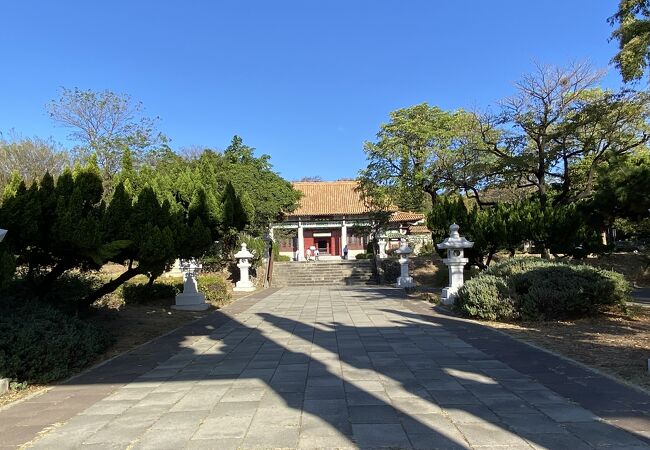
289,181,370,216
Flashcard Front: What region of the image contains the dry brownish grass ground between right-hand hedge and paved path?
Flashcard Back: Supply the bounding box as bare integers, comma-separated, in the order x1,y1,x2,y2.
482,307,650,390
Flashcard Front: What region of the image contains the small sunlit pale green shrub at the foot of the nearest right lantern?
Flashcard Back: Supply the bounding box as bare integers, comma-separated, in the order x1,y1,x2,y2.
454,274,518,320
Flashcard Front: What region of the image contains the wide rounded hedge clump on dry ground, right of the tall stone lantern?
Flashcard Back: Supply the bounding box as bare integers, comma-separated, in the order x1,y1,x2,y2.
454,258,630,321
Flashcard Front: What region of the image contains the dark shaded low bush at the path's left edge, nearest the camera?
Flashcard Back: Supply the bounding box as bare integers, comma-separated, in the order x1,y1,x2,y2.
0,302,112,383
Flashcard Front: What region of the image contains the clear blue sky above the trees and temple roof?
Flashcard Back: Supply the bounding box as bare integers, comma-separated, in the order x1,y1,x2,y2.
0,0,620,180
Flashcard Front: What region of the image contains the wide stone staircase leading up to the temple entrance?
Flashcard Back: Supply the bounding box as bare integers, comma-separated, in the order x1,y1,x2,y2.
271,260,377,287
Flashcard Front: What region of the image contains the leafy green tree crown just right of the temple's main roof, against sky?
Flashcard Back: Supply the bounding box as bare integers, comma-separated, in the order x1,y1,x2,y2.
359,103,480,211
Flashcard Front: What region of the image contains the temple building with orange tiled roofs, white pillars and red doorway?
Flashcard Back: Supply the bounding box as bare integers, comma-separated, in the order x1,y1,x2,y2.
271,181,431,261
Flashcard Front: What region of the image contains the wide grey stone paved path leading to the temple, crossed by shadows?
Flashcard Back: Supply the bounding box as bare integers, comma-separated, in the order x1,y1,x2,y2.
0,287,650,450
